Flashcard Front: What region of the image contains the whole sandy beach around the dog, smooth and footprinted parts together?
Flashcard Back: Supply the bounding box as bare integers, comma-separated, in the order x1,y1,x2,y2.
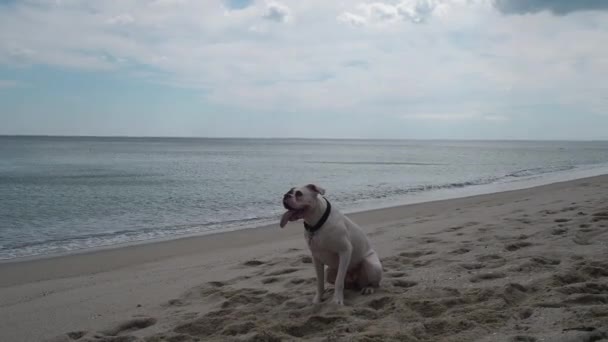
0,176,608,342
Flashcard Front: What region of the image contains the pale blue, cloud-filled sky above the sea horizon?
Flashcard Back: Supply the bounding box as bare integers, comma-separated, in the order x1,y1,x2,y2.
0,0,608,140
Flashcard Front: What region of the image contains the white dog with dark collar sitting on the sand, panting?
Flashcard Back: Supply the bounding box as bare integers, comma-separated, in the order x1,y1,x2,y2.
280,184,382,305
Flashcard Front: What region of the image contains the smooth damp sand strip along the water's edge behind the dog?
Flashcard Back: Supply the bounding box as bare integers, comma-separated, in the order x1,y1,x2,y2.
0,174,608,289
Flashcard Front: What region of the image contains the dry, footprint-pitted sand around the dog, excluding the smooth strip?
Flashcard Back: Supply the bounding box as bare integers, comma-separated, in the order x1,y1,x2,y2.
0,176,608,342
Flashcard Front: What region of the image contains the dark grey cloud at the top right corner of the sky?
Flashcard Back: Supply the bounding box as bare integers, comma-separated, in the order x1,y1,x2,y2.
494,0,608,15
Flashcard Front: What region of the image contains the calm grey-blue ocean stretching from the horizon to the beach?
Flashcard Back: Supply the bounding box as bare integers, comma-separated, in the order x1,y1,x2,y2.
0,136,608,260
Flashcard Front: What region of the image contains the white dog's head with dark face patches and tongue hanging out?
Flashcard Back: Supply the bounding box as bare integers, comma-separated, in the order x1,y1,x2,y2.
281,184,325,228
